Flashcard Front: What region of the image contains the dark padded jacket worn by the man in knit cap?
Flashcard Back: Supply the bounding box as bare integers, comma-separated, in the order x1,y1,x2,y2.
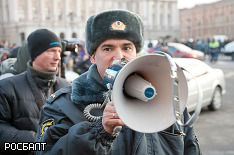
0,63,70,154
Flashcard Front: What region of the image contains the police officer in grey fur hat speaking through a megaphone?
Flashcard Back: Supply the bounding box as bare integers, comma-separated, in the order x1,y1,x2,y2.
37,10,200,155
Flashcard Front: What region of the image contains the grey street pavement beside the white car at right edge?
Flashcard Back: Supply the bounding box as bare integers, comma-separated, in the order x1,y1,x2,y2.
194,56,234,155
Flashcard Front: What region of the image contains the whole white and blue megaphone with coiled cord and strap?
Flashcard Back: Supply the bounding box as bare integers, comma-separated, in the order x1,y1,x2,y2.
84,52,202,134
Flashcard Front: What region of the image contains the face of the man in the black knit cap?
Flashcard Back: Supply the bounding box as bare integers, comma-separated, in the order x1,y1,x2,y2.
32,47,62,72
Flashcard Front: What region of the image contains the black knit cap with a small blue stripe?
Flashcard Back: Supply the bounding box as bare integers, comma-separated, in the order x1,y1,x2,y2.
27,29,62,61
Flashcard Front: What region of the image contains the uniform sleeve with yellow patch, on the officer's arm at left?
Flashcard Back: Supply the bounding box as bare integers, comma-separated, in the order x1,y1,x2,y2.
36,100,114,155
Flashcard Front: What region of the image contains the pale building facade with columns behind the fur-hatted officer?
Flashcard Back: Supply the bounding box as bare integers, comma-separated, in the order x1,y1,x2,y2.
0,0,179,45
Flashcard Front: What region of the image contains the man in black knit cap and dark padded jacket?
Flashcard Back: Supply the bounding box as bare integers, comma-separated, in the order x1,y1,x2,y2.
0,29,70,154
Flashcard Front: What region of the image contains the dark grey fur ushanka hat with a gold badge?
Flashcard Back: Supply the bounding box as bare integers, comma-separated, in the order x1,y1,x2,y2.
86,10,144,56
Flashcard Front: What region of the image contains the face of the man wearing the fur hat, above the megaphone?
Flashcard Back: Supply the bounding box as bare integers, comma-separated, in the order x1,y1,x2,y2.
91,39,137,79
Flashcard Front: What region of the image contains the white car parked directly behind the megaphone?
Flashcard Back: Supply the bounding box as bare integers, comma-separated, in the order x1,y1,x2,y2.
174,58,226,112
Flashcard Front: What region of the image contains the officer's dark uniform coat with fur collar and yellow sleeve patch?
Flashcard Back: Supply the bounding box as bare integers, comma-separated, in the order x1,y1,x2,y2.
37,65,200,155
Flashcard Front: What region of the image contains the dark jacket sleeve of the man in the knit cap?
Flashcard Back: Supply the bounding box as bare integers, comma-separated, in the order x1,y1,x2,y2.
0,87,36,153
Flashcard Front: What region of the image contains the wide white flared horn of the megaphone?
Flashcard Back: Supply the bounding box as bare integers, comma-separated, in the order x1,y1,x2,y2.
109,54,188,133
